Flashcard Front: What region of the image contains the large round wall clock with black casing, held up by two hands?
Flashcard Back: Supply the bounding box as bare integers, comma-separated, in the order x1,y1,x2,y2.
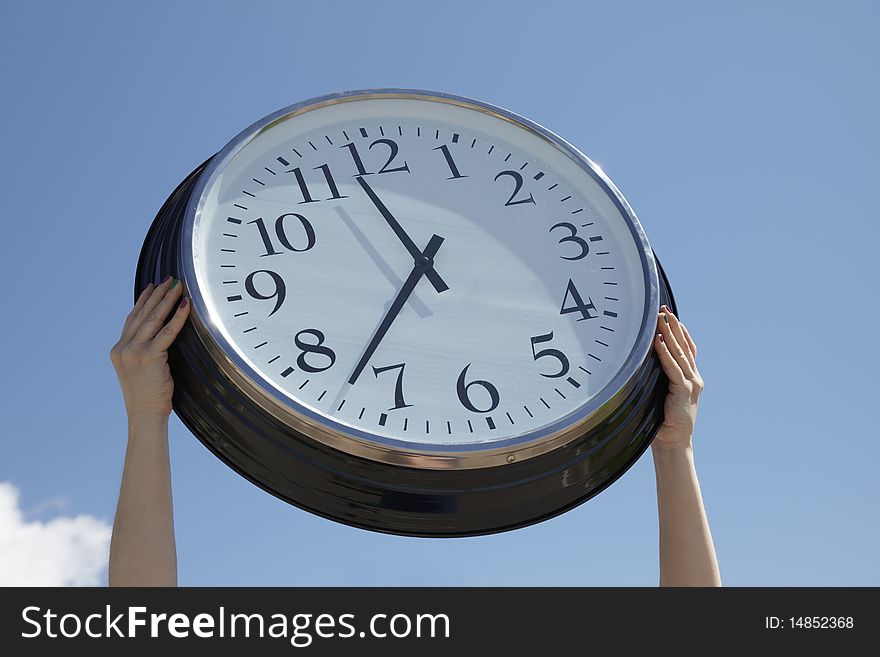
135,89,674,536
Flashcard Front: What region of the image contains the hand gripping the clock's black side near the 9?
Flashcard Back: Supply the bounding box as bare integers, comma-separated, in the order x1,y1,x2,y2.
110,276,190,421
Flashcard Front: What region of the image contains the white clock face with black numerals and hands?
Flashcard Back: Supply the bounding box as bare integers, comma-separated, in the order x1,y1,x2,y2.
187,98,646,451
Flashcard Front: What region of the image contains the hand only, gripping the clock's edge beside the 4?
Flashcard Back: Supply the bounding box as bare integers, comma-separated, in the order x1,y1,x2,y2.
651,305,703,449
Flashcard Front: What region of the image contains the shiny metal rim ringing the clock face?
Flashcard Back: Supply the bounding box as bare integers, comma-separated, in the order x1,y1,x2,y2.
178,89,660,470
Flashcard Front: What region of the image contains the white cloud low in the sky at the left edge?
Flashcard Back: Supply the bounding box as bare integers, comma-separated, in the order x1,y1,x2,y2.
0,482,110,586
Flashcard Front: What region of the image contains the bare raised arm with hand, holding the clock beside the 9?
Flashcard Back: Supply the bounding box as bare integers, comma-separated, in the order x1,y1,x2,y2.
109,279,189,586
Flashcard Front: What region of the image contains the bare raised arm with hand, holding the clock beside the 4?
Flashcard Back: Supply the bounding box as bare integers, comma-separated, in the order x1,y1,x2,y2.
651,306,721,586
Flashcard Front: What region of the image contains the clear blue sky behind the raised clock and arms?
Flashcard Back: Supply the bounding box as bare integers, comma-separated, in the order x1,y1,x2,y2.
0,0,880,586
